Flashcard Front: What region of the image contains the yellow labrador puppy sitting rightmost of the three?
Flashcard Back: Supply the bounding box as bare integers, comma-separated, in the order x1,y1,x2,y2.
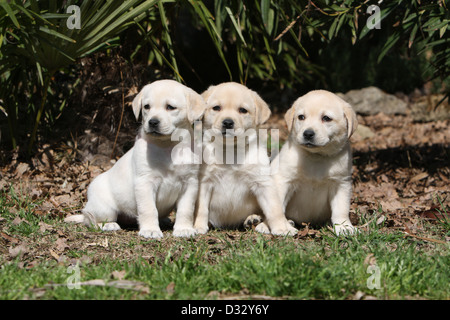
266,90,358,235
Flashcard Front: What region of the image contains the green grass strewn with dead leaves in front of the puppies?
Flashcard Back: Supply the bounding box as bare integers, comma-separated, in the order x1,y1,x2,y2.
0,188,450,299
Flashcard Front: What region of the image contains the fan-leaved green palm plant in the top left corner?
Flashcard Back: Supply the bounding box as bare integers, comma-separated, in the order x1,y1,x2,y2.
0,0,161,153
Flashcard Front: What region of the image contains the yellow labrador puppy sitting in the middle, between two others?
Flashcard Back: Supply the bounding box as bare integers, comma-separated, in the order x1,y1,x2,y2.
194,82,297,235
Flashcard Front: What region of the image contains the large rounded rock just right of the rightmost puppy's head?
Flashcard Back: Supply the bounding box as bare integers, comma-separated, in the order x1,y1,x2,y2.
340,87,407,115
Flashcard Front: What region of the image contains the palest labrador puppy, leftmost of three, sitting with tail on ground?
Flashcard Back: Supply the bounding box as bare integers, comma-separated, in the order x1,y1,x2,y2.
66,80,205,238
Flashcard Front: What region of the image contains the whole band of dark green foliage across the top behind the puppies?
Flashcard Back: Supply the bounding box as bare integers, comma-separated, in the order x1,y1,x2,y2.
0,0,450,152
